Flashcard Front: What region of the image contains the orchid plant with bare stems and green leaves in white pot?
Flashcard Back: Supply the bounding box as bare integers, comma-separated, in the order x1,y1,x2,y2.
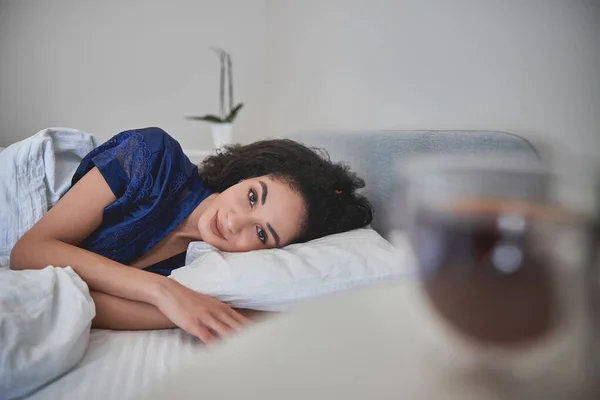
187,47,244,148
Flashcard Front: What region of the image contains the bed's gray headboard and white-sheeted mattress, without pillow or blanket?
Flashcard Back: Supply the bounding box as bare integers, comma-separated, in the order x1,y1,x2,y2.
7,131,538,400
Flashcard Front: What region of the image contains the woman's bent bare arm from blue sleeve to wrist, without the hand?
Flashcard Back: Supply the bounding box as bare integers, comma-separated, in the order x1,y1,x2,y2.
10,168,167,303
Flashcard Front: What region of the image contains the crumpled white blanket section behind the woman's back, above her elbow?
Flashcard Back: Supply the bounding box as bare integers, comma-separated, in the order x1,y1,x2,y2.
0,128,97,268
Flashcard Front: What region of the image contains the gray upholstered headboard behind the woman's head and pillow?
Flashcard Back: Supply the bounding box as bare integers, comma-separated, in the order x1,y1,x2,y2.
288,131,538,234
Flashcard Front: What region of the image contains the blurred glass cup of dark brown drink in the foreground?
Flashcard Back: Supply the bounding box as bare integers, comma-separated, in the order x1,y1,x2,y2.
390,156,600,400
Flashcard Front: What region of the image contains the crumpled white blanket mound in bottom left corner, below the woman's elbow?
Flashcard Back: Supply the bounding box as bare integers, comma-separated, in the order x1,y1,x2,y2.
0,266,96,400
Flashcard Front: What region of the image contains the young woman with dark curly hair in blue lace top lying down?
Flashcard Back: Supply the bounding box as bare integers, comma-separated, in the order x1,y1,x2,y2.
10,128,372,342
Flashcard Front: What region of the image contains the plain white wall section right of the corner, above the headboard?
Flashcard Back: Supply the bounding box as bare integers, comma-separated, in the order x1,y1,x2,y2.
266,0,600,155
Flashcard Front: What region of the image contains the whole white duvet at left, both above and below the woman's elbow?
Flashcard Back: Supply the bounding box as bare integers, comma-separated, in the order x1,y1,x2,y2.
0,128,96,400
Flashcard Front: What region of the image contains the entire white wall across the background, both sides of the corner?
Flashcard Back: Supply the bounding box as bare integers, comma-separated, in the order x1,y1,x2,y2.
0,0,600,155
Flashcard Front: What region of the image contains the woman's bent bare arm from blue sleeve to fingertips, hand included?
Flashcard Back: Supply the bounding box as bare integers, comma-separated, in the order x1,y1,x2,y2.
10,168,247,341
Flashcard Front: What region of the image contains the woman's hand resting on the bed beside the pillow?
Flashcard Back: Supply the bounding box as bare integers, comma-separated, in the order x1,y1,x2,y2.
154,279,250,343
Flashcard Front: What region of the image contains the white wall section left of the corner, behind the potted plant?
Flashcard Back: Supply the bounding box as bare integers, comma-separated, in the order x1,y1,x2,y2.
0,0,266,148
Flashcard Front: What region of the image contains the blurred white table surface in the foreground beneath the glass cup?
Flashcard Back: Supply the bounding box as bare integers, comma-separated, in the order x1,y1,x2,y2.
151,283,592,400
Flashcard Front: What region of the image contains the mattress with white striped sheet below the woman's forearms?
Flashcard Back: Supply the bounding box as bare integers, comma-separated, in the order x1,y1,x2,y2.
27,329,210,400
